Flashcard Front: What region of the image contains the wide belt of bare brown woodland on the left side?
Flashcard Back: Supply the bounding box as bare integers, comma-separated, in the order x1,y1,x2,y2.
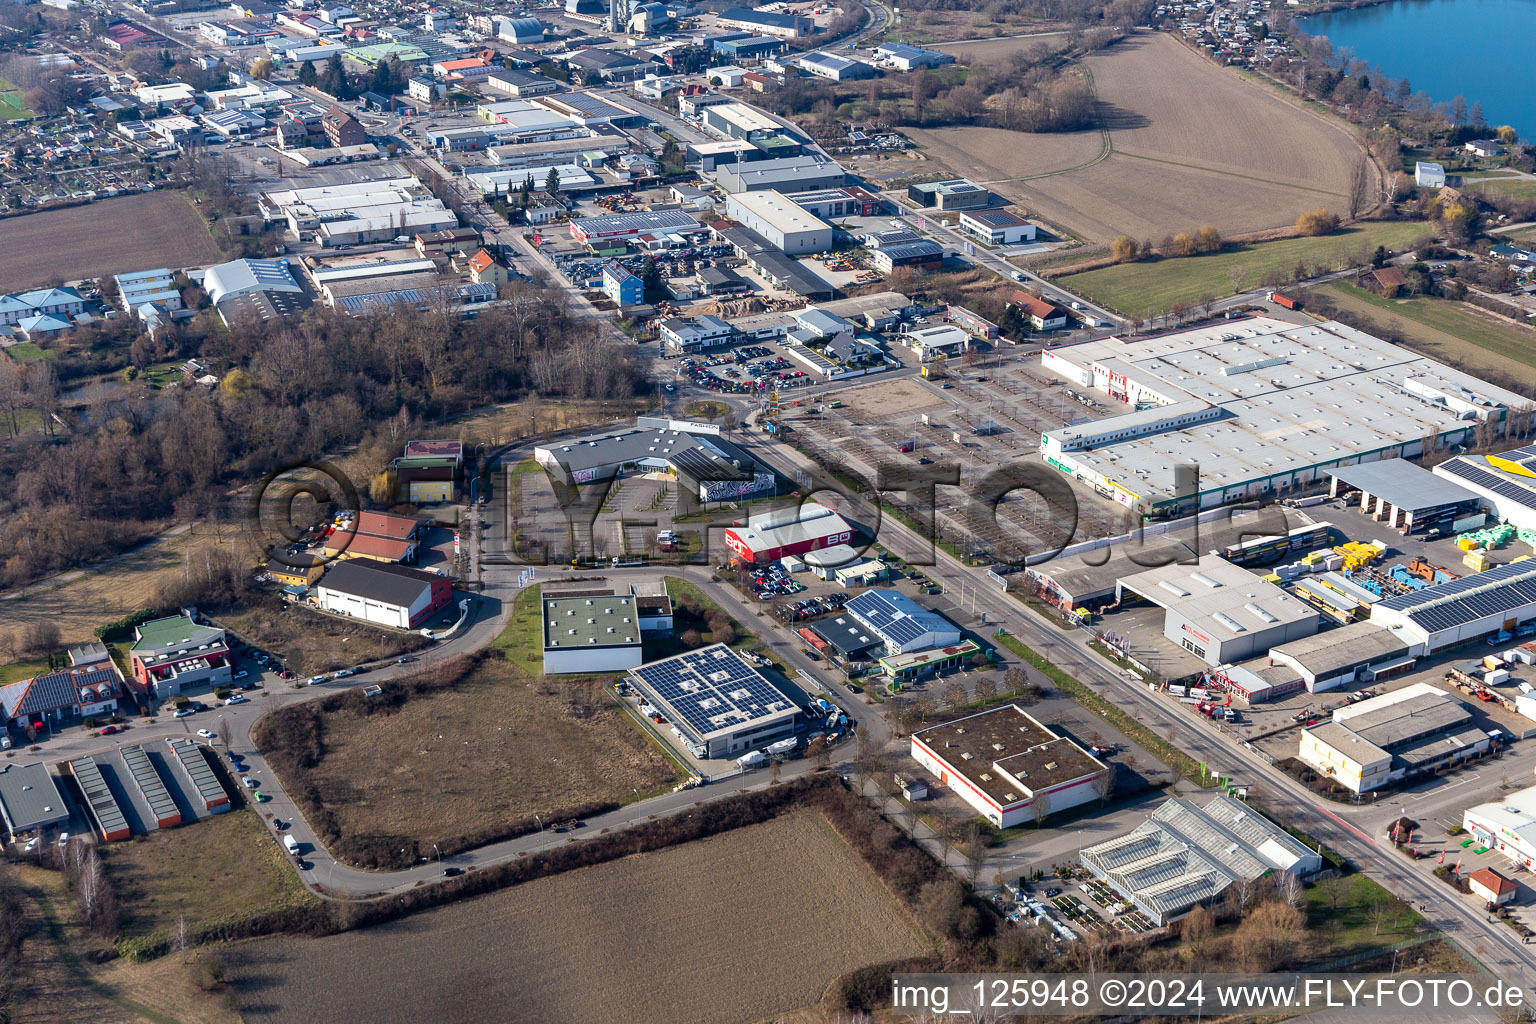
0,260,636,585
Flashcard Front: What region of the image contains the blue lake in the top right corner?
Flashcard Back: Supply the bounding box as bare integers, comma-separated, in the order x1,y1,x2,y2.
1299,0,1536,138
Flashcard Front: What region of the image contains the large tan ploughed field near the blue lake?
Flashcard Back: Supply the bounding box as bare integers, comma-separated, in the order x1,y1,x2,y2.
914,32,1359,243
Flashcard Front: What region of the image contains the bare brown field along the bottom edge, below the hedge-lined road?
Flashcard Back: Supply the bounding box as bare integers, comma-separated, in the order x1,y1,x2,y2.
227,812,926,1024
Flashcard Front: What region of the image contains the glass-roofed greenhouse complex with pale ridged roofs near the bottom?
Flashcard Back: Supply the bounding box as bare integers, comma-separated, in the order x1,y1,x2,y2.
1077,797,1322,924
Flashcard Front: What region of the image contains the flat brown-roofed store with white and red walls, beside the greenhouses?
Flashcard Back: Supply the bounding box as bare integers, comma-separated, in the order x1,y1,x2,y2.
912,705,1114,829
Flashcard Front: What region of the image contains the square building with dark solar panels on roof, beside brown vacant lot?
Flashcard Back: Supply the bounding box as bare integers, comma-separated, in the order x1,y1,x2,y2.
631,643,794,740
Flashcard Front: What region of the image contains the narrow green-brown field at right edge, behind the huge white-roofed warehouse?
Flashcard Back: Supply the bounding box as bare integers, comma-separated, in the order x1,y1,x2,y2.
1326,281,1536,387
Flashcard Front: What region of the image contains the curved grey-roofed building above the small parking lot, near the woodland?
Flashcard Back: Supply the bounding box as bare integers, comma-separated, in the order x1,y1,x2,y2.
533,416,777,502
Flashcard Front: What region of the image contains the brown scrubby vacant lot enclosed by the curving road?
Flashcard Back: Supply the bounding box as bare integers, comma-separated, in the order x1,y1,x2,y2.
284,656,679,847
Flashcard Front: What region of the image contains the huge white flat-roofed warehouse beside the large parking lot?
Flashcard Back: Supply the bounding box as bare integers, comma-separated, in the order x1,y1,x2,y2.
1040,316,1531,513
